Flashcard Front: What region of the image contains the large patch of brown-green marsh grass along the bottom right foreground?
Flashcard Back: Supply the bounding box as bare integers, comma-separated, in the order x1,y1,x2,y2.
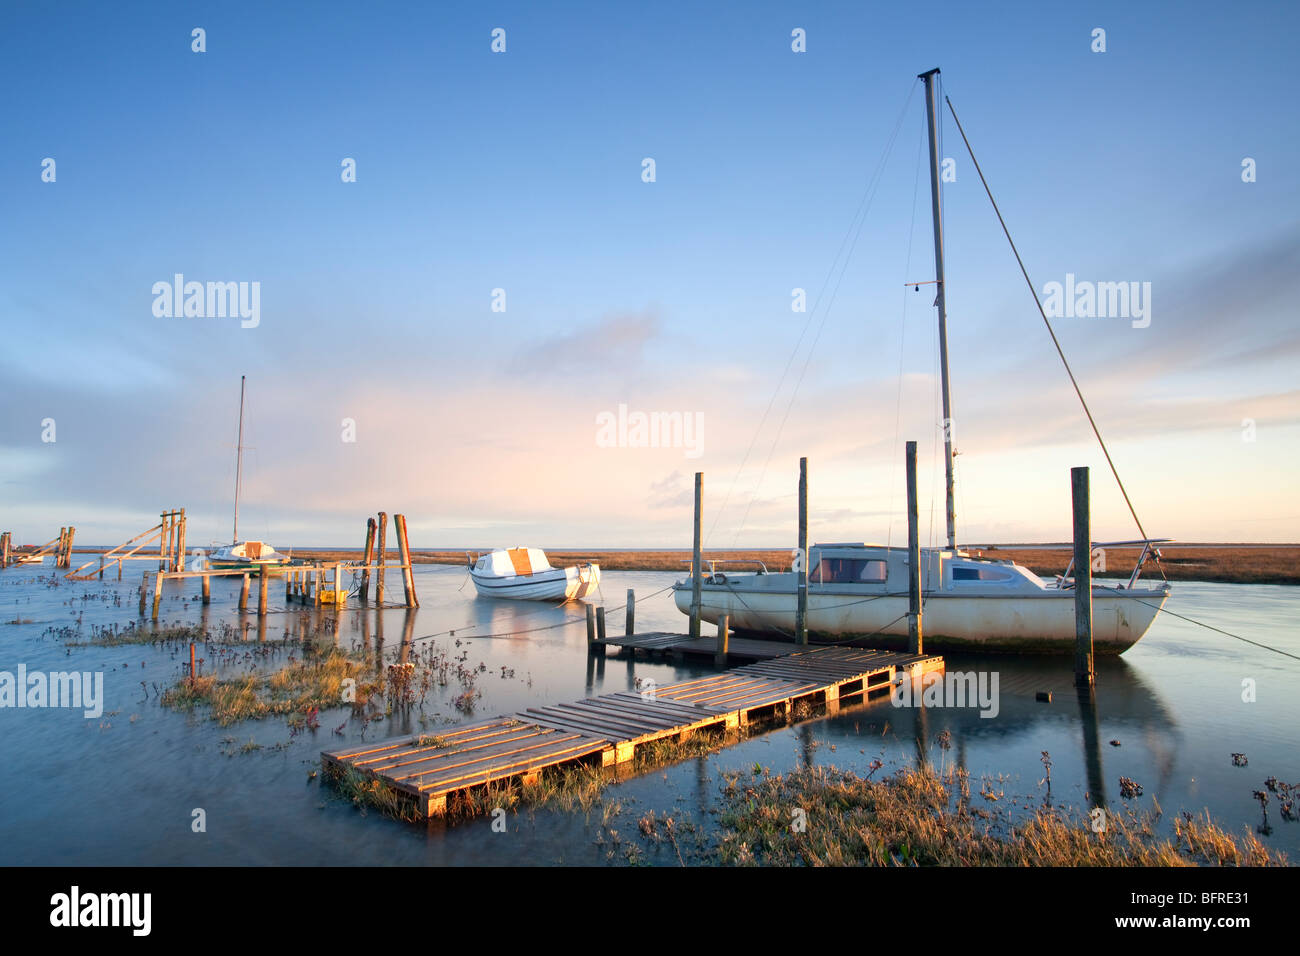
715,767,1286,866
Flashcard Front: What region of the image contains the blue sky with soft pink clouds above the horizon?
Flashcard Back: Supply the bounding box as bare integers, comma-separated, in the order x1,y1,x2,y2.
0,3,1300,550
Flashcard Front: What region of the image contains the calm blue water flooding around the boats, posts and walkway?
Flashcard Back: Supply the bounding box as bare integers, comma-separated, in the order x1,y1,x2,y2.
0,566,1300,865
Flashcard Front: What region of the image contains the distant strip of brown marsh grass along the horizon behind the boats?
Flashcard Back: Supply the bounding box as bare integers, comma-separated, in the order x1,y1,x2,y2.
294,544,1300,584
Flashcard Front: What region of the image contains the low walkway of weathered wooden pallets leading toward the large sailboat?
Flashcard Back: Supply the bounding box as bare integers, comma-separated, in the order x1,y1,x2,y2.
321,641,944,817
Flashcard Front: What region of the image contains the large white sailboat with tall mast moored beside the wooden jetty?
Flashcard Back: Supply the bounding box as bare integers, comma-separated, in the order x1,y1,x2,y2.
673,69,1170,654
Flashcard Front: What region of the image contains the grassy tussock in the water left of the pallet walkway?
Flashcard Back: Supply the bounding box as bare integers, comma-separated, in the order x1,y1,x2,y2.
163,648,374,727
